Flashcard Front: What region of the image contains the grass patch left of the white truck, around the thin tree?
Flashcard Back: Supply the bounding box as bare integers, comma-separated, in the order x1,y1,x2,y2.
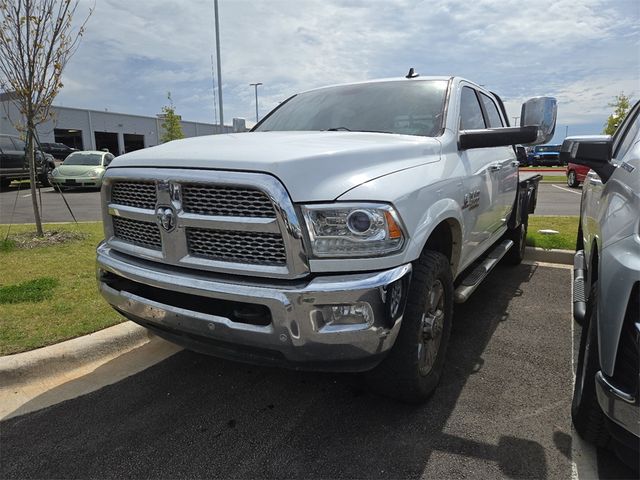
0,222,123,355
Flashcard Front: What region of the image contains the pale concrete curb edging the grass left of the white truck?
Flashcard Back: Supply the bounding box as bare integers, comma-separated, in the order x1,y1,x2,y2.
0,321,153,387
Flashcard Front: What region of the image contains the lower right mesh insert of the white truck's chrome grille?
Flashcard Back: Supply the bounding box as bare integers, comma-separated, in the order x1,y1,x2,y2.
187,228,287,265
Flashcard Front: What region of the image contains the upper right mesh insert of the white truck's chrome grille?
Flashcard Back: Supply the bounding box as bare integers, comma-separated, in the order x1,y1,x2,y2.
182,184,276,218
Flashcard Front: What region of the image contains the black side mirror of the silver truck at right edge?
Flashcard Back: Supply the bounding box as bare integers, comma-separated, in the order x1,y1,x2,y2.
560,135,616,183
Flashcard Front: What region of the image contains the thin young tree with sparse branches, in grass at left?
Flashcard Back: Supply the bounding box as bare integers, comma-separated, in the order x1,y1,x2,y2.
0,0,92,236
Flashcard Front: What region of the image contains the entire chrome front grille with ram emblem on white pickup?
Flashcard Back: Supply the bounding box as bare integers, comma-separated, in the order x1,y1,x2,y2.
102,168,309,278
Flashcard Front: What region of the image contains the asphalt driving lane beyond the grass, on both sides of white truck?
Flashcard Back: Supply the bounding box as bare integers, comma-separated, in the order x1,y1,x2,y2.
0,184,582,223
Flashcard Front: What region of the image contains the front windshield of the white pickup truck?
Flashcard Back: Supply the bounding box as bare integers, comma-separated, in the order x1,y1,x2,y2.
254,80,448,137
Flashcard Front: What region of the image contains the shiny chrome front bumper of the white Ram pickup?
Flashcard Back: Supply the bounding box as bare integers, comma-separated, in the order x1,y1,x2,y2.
97,244,411,371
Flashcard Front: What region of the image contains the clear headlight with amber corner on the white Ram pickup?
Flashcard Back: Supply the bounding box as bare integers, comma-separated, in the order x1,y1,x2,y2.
302,203,404,257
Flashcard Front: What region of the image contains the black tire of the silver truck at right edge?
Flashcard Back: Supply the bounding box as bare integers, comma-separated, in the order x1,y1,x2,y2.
571,282,610,447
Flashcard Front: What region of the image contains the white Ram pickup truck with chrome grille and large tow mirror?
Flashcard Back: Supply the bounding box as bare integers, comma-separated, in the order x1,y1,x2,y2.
97,72,556,402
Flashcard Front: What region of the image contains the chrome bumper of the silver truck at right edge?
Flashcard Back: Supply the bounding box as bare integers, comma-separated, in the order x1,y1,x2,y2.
596,372,640,437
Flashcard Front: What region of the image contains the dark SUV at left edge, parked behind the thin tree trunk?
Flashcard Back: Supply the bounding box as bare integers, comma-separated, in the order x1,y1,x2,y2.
0,135,56,188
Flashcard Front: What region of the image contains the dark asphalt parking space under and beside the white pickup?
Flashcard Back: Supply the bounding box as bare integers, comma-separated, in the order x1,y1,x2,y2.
0,265,633,479
